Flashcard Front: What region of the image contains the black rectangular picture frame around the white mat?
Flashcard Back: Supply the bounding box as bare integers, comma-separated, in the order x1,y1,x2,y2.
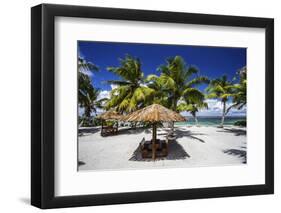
31,4,274,209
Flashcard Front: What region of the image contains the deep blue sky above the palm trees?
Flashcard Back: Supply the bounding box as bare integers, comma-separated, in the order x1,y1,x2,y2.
78,41,246,115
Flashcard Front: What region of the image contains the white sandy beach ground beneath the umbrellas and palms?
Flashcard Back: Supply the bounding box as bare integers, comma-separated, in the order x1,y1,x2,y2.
78,126,247,171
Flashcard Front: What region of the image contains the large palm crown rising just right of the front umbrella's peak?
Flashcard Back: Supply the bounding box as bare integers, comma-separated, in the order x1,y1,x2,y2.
158,56,209,111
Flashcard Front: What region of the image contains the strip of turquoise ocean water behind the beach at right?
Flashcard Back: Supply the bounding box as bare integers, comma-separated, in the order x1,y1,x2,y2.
175,116,246,126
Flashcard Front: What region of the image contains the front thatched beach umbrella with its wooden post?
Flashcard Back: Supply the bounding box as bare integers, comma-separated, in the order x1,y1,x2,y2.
122,104,186,159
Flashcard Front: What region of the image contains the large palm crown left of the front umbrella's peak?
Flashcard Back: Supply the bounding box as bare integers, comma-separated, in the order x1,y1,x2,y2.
106,55,154,113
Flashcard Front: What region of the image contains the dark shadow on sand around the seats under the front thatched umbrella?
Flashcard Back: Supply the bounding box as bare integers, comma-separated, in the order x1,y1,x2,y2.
129,141,190,161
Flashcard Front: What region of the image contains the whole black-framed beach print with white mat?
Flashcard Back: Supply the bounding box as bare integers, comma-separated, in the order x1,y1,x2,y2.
31,4,274,208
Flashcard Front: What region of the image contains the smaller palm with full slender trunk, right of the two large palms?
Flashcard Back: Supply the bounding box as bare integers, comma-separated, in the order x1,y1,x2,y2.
206,75,235,127
